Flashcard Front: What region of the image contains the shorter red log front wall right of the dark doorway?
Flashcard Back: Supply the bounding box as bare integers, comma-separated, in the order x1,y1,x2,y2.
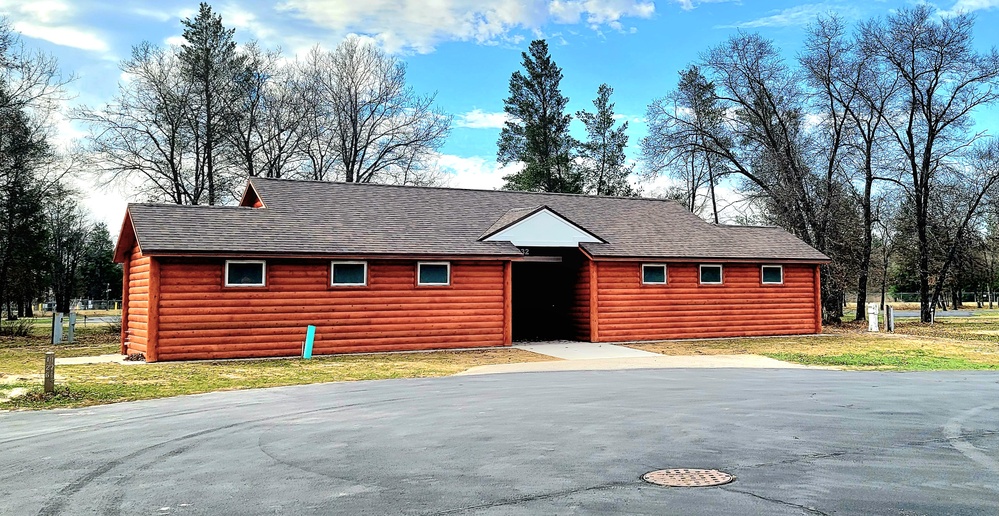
596,262,817,342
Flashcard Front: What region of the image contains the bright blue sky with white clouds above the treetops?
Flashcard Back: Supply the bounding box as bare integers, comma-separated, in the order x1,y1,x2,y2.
0,0,999,231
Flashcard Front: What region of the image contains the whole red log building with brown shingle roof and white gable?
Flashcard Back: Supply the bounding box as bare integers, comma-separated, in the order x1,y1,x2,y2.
115,178,828,361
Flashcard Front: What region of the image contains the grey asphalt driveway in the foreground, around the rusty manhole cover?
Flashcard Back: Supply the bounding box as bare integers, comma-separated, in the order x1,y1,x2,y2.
0,369,999,515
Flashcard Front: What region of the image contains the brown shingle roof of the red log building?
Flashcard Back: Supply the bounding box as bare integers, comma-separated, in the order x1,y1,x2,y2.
123,178,828,261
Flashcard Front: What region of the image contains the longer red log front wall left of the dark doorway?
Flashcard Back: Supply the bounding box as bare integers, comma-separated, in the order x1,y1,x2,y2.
156,259,505,360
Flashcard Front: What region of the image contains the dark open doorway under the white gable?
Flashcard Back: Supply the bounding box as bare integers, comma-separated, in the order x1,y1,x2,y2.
512,249,582,341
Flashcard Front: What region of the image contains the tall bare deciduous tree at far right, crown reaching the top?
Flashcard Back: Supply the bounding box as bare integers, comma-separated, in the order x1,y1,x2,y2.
861,5,999,322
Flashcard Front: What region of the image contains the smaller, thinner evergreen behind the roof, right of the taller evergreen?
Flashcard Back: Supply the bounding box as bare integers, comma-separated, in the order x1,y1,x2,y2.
576,84,634,195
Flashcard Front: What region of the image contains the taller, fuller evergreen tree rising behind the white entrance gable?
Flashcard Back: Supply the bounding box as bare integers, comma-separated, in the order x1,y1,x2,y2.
496,39,583,193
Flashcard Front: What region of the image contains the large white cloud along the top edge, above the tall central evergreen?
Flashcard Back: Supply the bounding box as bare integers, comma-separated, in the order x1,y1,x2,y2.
277,0,655,52
